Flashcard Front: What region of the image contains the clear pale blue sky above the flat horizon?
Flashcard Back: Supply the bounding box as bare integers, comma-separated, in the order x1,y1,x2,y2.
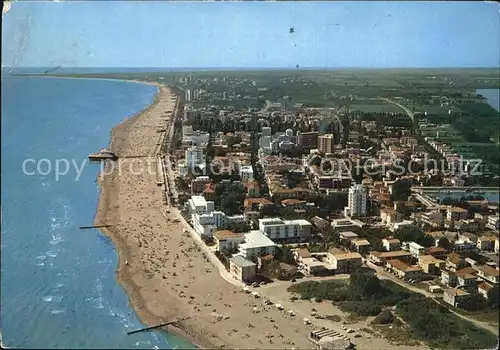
2,1,500,68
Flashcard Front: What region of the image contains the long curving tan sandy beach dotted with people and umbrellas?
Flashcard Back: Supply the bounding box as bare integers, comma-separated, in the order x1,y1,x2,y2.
95,80,430,349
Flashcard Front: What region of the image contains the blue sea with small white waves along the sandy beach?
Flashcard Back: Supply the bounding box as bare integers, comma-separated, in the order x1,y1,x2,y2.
0,76,195,349
